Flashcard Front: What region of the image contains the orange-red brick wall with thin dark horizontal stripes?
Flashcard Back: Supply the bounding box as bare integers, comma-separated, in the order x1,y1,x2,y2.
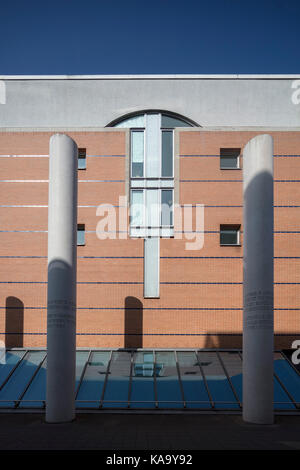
0,129,300,348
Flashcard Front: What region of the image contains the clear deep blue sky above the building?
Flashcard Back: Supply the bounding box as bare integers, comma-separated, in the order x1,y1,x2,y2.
0,0,300,75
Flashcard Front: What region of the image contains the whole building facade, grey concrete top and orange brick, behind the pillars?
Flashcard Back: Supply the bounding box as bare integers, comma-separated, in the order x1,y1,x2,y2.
0,76,300,348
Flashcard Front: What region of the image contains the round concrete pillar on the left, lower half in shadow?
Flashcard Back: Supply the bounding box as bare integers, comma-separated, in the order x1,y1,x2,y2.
46,134,78,423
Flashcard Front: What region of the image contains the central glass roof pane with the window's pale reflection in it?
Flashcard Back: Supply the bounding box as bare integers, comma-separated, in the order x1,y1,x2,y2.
130,352,155,408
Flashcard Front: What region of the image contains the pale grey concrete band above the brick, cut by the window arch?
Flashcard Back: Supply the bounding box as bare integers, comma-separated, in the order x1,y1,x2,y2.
0,75,300,128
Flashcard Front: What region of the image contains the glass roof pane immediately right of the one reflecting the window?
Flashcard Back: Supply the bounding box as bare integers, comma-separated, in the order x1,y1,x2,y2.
156,351,183,408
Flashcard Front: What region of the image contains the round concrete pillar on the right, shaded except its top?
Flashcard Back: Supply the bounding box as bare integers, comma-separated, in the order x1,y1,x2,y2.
243,135,274,424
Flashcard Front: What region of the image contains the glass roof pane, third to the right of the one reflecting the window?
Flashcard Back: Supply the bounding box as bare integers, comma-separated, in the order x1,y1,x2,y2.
198,351,239,409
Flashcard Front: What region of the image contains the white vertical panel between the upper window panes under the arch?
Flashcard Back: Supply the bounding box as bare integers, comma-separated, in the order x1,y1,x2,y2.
146,114,161,178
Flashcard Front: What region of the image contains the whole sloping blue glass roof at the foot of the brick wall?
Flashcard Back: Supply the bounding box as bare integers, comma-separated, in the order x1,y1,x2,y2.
0,349,300,412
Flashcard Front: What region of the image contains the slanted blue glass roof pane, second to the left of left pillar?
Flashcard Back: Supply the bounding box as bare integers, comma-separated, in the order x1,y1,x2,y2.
0,351,46,408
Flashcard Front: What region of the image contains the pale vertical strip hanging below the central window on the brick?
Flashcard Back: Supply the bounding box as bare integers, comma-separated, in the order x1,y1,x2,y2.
144,237,160,298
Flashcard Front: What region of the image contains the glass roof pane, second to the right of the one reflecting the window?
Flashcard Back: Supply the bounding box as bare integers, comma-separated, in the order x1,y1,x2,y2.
177,351,210,409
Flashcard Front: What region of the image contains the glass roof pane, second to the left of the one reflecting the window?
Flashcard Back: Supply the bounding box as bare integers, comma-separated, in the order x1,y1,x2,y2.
76,351,110,408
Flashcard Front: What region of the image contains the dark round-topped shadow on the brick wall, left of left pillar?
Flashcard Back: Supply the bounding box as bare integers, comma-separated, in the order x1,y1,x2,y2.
5,297,24,348
